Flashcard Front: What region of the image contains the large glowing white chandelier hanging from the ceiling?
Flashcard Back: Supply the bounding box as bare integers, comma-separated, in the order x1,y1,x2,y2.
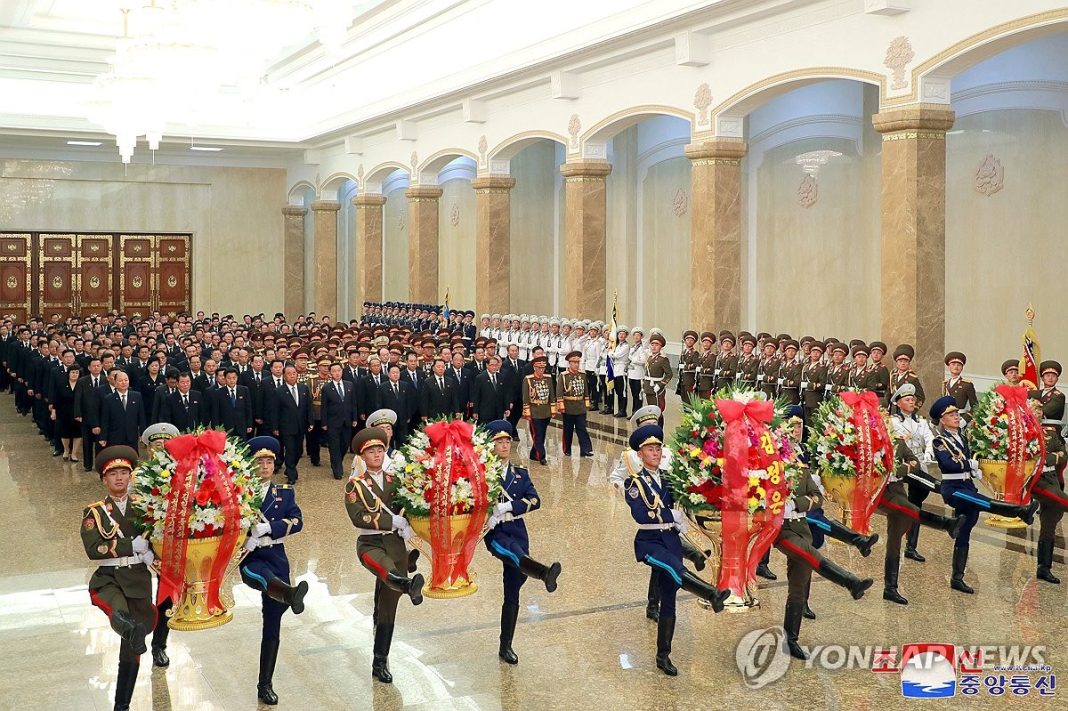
88,0,356,163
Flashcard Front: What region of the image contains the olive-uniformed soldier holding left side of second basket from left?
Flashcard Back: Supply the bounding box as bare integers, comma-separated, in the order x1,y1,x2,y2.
345,427,423,684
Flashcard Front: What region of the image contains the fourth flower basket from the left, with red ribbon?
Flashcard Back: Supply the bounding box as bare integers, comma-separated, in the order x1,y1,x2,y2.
808,391,894,534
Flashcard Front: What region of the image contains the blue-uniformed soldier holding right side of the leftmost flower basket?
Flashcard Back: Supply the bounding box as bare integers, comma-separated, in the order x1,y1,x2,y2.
240,437,308,706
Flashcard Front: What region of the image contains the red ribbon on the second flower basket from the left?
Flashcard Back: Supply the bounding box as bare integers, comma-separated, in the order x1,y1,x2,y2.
424,420,489,587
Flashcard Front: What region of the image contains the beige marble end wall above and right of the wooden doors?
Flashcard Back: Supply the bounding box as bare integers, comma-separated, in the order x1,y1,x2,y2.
0,160,286,314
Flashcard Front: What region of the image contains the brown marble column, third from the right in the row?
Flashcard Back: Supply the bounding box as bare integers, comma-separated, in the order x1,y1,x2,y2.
560,160,612,319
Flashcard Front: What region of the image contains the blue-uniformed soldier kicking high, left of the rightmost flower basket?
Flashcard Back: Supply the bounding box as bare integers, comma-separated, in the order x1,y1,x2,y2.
931,395,1038,594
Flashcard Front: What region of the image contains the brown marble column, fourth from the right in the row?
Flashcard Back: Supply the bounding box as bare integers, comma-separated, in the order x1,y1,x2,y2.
471,175,516,321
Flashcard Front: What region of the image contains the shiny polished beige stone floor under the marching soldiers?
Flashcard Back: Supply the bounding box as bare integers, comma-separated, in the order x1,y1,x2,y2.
0,394,1068,711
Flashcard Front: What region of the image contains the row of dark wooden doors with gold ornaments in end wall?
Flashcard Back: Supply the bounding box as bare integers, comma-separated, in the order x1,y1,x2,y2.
0,232,192,322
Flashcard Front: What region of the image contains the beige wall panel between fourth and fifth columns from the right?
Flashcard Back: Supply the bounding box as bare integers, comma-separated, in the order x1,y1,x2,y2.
438,179,478,309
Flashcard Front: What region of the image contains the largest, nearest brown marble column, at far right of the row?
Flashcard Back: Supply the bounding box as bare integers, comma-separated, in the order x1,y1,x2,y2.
871,105,954,392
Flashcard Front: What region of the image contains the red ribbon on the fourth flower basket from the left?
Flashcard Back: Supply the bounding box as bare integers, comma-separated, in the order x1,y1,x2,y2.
842,391,894,534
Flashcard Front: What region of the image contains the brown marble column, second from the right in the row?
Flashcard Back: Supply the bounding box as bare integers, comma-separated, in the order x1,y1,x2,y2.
686,138,747,333
